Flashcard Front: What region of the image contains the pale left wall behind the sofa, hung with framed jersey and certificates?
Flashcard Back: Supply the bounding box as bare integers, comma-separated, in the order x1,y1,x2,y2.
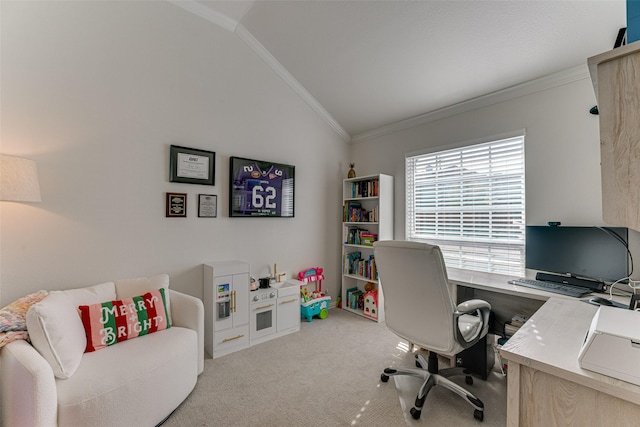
0,1,348,305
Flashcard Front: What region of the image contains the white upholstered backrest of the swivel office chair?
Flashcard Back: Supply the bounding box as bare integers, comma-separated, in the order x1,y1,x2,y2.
374,240,455,353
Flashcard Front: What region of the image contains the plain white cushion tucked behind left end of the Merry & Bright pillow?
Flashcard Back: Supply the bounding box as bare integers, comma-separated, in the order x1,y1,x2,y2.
27,282,115,379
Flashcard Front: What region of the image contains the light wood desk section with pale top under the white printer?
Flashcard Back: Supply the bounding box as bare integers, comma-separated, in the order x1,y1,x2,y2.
500,297,640,427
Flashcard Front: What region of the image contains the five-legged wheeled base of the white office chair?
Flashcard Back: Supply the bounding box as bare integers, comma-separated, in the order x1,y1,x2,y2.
380,352,484,421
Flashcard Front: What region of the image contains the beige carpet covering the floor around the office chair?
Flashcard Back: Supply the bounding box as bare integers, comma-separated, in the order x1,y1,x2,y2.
163,309,506,427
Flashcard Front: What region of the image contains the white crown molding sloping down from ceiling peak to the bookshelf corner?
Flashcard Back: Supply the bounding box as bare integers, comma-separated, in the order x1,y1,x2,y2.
235,24,351,142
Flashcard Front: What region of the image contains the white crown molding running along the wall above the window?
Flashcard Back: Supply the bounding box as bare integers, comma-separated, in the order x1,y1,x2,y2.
351,64,590,142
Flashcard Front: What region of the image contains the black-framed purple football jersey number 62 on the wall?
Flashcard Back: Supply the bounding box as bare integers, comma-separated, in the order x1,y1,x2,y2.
229,157,295,218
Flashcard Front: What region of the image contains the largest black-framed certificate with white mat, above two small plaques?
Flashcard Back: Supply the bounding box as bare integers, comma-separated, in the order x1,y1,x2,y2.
169,145,216,185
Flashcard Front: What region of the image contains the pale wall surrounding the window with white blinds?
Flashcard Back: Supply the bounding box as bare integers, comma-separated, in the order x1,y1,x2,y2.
351,76,640,277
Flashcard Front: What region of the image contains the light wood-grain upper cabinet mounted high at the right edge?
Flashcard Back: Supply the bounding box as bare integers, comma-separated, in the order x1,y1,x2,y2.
588,42,640,230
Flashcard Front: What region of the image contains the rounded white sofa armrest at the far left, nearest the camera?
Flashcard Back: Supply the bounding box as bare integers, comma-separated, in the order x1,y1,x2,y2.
0,340,58,427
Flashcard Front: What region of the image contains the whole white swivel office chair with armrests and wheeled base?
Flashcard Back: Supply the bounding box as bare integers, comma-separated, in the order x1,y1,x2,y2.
374,241,491,421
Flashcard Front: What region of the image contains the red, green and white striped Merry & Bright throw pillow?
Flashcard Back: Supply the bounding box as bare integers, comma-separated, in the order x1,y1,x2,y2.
78,288,171,352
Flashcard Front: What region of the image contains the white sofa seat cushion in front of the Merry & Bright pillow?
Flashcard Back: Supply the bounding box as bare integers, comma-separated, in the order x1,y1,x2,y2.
56,327,198,426
